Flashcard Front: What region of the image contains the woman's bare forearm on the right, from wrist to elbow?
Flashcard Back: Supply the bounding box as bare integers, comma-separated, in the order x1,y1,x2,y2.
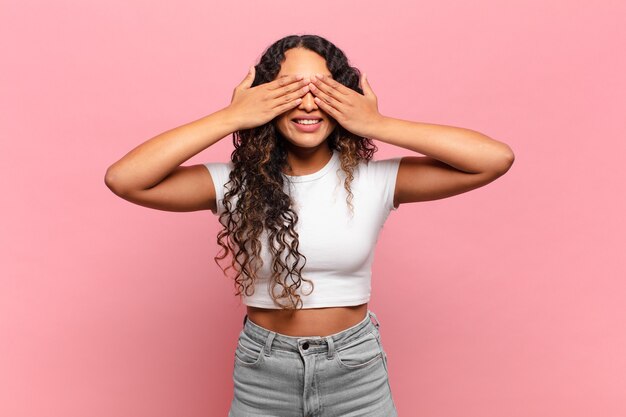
368,116,515,173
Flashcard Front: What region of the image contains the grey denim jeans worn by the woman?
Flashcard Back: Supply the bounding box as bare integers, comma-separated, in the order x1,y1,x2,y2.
228,310,398,417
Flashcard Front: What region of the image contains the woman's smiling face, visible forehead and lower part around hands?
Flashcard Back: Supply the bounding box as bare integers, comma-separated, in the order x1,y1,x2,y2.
274,48,337,150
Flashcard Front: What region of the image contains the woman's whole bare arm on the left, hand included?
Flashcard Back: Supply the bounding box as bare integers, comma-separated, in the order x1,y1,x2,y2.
104,70,309,212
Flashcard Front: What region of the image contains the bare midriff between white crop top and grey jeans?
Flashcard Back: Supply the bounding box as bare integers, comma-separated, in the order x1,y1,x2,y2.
247,303,367,337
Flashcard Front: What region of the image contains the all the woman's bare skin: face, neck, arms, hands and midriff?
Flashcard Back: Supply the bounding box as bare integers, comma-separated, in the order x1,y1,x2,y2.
105,48,514,336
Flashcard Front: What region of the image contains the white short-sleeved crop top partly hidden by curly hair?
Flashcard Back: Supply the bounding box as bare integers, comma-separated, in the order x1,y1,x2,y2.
204,151,402,309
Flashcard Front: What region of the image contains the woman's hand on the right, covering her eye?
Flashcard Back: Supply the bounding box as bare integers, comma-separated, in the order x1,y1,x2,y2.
311,74,383,137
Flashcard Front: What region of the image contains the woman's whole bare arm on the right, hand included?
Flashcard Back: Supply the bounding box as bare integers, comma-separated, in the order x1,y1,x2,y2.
311,73,515,207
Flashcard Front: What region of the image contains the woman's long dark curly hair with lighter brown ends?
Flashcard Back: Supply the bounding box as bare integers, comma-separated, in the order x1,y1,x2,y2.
215,34,378,310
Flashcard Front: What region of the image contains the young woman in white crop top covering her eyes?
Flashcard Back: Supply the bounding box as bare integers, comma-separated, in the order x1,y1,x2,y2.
105,35,514,417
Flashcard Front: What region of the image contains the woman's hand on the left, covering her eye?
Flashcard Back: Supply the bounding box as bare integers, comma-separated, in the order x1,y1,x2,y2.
226,66,309,130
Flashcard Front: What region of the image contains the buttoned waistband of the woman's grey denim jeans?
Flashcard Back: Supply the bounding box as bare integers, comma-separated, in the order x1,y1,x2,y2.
242,309,380,356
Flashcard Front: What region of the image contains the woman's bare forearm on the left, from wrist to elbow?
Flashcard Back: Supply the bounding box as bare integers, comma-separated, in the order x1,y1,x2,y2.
105,107,238,193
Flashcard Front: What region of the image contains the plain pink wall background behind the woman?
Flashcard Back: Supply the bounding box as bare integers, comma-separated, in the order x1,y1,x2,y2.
0,0,626,417
